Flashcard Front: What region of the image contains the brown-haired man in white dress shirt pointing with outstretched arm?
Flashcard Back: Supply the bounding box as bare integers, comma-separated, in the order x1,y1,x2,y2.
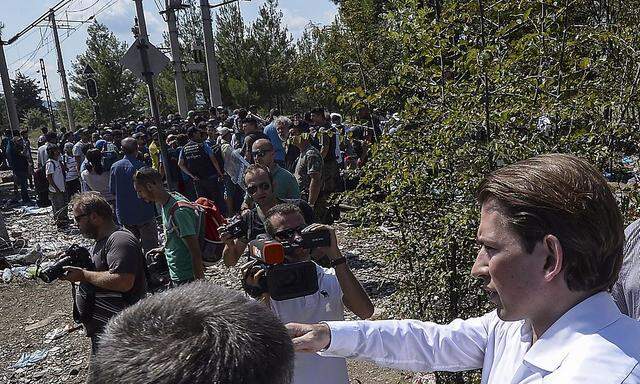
287,154,640,384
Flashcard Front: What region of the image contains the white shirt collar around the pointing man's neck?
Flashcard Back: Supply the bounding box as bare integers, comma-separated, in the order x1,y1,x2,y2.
524,292,622,372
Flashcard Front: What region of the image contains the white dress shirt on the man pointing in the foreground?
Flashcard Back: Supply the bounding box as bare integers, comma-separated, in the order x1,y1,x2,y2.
320,292,640,384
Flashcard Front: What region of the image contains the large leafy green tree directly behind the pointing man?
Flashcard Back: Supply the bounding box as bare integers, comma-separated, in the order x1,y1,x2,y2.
333,0,640,383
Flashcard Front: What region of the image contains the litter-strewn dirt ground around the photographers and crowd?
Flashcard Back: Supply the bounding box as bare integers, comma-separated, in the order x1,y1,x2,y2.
0,184,432,384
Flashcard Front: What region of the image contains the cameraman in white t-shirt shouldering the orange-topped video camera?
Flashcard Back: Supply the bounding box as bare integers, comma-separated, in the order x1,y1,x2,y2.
245,204,373,384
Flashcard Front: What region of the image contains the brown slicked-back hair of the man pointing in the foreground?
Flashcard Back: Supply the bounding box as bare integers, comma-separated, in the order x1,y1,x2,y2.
478,154,624,291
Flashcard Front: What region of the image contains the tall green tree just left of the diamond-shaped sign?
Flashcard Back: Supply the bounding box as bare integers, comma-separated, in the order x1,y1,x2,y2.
71,22,138,124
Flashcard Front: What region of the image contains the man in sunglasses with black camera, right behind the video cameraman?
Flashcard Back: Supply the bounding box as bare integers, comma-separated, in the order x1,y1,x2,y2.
220,164,315,267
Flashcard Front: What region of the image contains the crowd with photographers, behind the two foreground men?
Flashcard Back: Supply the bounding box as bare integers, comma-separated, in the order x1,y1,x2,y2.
3,107,382,383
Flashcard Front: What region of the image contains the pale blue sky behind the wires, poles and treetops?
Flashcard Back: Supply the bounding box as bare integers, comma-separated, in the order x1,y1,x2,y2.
0,0,337,100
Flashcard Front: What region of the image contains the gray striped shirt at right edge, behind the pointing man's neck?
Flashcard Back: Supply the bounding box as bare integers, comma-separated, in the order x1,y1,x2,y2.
611,220,640,320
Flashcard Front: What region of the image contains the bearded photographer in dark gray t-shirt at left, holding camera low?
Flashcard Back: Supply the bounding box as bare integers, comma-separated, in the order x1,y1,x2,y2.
60,192,146,353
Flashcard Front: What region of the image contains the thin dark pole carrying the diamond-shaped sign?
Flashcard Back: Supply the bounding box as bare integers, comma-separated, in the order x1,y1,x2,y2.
134,0,175,190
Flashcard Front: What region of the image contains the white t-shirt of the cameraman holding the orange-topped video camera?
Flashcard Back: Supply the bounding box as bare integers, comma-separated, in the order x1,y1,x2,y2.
271,265,349,384
